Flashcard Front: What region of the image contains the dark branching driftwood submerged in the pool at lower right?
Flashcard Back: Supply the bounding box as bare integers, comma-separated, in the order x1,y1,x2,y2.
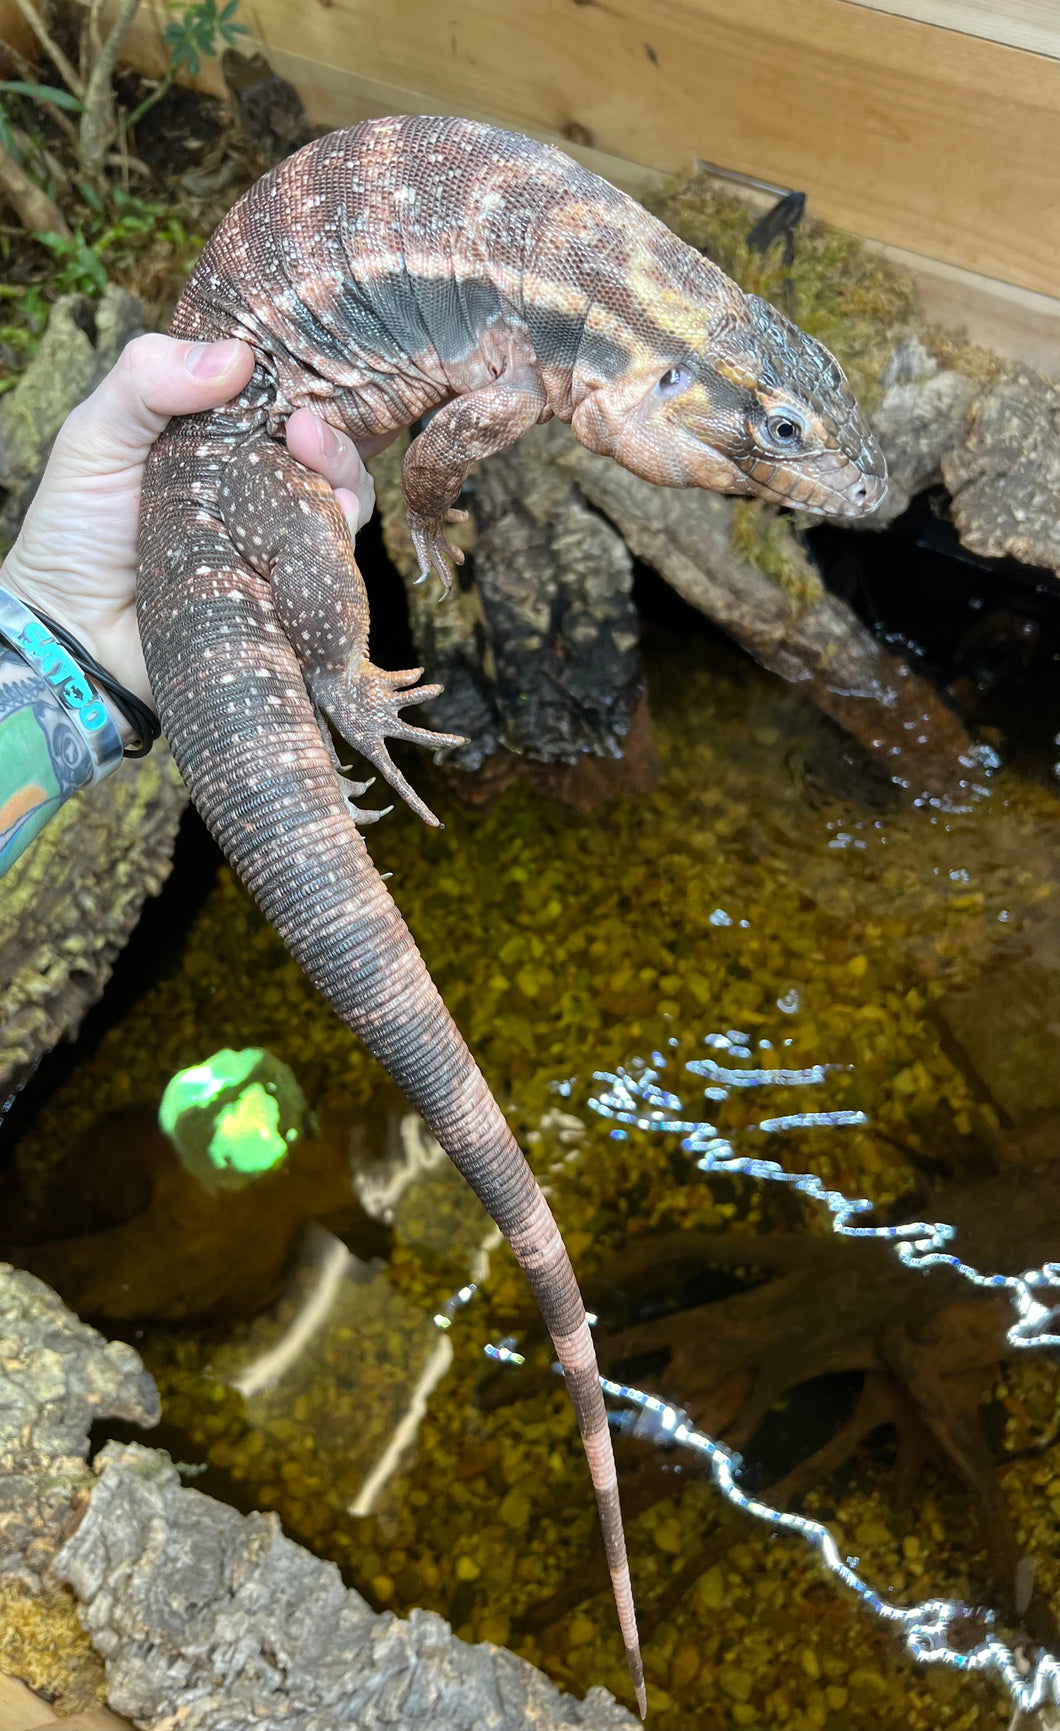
502,1156,1058,1650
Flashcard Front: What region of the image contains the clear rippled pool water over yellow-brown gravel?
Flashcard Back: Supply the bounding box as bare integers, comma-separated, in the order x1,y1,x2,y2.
3,644,1060,1731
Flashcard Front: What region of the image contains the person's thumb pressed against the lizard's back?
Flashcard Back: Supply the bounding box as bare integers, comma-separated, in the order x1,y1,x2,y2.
55,334,255,474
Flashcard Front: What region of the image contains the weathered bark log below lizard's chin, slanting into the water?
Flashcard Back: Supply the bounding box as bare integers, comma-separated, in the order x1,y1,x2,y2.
376,422,977,800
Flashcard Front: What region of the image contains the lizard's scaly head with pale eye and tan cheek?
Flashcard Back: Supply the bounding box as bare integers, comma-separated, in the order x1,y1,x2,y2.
572,294,887,518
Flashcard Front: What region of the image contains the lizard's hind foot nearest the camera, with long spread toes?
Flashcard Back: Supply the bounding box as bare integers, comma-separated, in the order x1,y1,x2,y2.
313,660,468,829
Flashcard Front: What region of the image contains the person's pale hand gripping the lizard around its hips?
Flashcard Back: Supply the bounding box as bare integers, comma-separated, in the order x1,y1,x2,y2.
0,336,376,701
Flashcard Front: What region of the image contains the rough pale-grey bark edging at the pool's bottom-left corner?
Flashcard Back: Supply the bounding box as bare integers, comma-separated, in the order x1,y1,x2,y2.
0,1264,636,1731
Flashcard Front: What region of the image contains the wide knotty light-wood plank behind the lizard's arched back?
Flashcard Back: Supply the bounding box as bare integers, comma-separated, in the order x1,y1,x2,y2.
109,0,1060,294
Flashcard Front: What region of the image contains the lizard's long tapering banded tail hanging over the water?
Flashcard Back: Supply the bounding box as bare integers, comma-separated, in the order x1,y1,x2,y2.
139,488,646,1715
